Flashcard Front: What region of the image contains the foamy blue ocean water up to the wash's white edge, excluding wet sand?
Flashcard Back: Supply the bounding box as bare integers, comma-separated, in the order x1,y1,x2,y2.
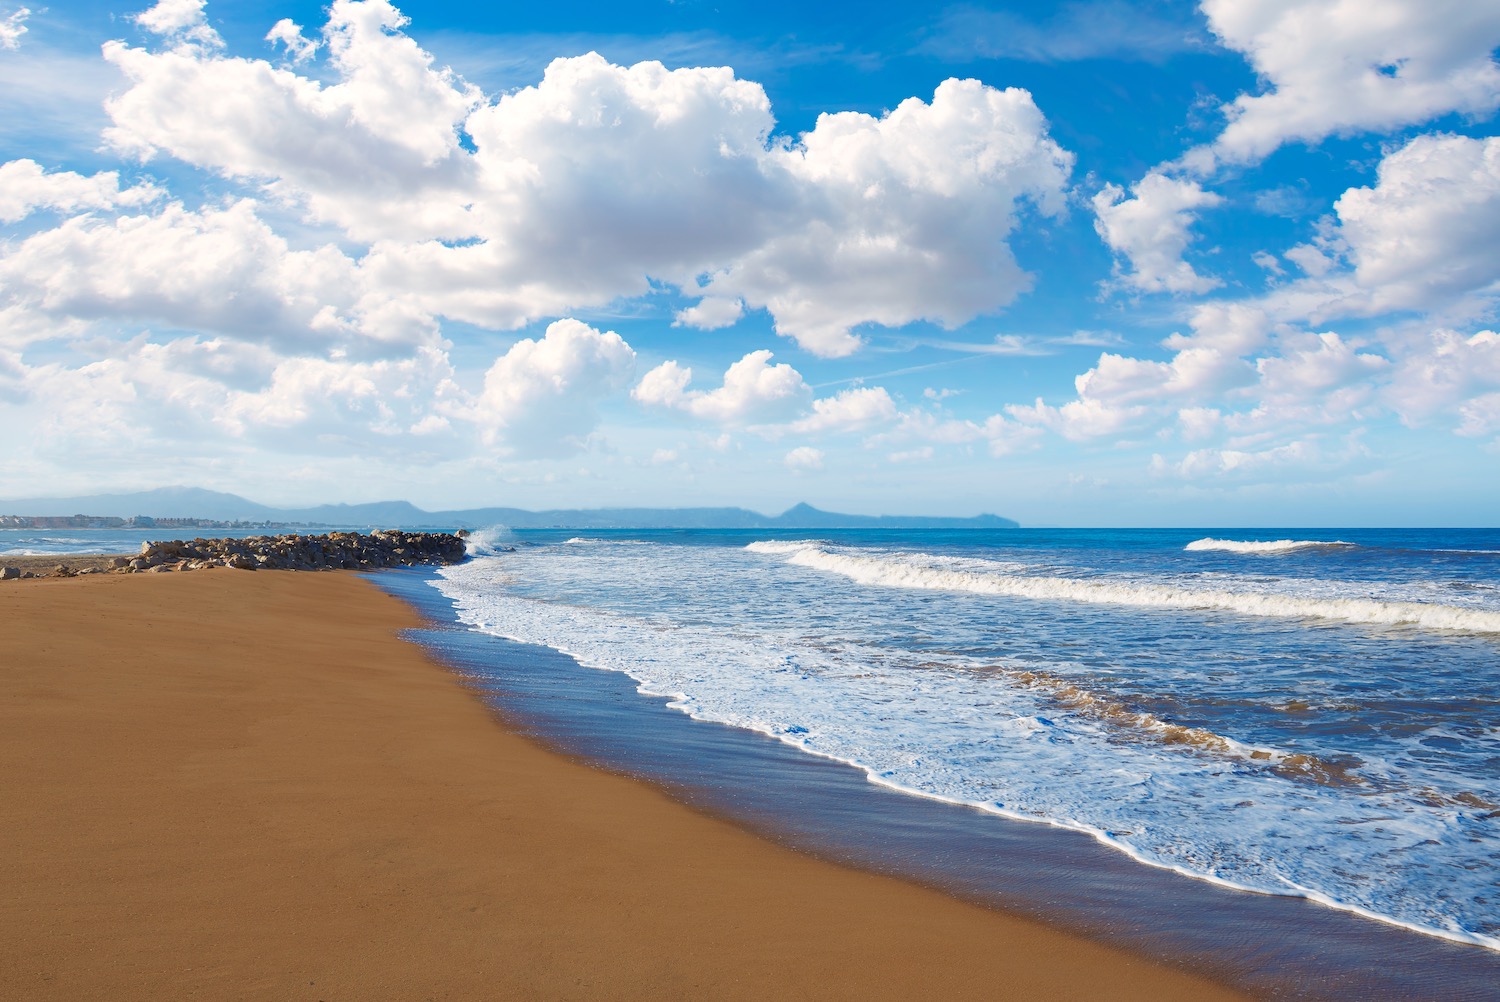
434,530,1500,950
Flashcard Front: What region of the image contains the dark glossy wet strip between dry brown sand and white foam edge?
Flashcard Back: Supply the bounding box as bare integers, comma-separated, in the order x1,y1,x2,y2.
390,572,1500,999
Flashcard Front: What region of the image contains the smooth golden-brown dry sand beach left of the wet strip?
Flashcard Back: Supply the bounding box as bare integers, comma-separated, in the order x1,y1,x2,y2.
0,570,1242,999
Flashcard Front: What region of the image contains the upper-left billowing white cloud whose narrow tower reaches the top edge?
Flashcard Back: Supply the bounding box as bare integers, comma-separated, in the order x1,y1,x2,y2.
104,0,480,240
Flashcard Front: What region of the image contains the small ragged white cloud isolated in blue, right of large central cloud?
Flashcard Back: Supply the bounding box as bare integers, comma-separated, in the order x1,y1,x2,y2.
1094,173,1224,293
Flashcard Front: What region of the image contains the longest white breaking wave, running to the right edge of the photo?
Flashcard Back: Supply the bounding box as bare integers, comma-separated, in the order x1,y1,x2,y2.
746,543,1500,633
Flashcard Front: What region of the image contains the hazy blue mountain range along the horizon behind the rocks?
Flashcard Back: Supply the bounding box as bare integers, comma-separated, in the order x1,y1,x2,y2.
0,488,1016,530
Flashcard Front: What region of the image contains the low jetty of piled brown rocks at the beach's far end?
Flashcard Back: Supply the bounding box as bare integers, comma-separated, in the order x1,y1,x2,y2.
0,530,468,581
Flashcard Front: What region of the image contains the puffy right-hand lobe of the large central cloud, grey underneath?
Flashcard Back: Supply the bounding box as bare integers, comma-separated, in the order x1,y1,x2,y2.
690,80,1073,356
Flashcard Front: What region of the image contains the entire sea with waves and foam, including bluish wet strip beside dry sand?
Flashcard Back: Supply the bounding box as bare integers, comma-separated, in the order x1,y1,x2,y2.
14,527,1500,999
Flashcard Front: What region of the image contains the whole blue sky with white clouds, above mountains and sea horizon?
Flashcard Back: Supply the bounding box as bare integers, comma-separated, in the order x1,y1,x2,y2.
0,0,1500,527
